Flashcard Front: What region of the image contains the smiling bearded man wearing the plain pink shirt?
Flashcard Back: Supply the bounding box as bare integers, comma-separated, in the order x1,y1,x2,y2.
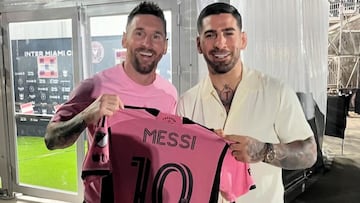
45,2,177,202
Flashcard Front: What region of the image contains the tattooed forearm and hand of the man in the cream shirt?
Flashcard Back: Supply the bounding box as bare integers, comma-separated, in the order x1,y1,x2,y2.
223,135,317,170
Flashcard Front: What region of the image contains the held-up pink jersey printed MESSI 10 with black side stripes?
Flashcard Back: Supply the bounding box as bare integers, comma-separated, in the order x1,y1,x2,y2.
108,109,253,203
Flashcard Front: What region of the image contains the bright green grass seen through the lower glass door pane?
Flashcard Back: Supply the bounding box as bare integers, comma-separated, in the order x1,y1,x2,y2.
17,136,77,192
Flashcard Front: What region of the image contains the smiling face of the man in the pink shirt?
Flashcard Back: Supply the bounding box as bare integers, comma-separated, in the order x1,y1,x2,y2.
122,14,167,74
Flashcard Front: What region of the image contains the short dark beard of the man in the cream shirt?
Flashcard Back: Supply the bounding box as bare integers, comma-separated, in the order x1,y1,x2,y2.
204,54,240,74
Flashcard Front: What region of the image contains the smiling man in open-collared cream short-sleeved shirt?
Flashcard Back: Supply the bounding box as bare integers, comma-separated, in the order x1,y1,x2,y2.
177,2,317,203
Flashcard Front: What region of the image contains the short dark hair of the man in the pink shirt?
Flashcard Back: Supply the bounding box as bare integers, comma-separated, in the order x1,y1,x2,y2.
126,1,166,35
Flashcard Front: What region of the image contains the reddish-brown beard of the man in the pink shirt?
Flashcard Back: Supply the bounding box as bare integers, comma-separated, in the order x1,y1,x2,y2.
130,49,161,75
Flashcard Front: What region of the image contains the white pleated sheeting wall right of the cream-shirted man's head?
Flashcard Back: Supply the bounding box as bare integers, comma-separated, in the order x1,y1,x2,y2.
230,0,329,115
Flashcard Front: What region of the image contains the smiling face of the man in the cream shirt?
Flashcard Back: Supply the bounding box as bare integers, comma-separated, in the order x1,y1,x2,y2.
197,13,247,74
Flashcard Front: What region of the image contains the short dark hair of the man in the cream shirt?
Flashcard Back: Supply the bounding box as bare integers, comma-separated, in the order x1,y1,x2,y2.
197,2,242,33
